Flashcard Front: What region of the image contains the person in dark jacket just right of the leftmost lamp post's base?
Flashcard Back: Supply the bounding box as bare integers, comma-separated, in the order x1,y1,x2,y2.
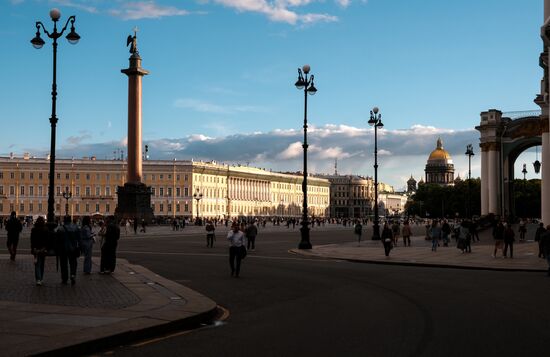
56,216,80,285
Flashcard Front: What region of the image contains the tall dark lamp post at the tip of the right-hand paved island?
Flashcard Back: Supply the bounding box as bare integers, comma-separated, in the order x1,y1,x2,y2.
294,64,317,249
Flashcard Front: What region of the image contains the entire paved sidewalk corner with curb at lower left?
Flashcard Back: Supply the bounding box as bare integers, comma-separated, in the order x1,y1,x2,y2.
0,255,220,356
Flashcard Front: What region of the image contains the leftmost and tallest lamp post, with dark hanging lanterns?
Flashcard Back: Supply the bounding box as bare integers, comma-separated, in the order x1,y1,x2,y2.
31,9,80,227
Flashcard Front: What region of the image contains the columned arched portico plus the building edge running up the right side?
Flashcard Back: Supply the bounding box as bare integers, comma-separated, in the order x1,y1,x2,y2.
477,0,550,224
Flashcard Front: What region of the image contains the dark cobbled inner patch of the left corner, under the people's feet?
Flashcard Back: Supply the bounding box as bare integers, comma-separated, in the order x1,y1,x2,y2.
0,255,139,309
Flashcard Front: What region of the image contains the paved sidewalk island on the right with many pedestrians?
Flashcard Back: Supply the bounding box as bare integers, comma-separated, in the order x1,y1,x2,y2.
291,237,548,272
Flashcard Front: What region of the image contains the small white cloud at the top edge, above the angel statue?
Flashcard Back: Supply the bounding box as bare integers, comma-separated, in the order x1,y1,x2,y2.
109,1,189,20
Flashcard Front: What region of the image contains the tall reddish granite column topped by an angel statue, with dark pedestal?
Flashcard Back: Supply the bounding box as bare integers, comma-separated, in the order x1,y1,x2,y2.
116,29,153,222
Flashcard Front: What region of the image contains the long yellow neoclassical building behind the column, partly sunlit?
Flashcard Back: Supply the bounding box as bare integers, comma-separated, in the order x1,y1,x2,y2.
0,155,330,218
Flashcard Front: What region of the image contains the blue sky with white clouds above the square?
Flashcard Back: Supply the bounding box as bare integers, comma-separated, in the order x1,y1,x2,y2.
0,0,543,189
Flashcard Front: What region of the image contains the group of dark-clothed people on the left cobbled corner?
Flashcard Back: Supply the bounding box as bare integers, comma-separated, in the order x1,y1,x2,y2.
6,212,120,286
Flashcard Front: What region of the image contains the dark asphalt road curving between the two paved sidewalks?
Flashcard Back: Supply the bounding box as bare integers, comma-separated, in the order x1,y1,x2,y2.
83,225,550,357
